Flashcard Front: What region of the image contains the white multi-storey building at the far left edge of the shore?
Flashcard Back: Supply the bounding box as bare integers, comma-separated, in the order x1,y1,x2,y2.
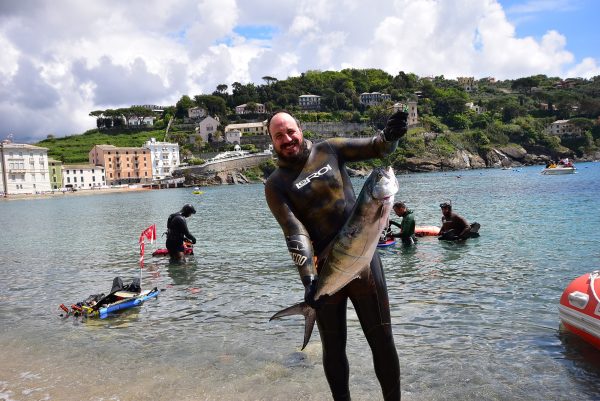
0,141,51,195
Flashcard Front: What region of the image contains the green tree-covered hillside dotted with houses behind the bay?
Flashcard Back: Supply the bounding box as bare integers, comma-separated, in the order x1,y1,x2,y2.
38,69,600,167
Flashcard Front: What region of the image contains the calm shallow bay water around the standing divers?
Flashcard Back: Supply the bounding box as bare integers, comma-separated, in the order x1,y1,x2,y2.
0,163,600,401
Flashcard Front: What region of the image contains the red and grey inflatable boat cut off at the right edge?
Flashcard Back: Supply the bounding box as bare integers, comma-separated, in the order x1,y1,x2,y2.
558,270,600,349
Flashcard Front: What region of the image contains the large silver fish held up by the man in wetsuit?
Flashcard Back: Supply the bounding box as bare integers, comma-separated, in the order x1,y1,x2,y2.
269,167,398,349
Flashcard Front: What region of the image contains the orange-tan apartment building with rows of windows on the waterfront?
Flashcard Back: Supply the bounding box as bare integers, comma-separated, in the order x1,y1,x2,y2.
88,145,152,185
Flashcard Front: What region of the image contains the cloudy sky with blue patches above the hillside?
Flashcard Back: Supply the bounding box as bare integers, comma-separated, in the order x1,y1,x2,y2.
0,0,600,143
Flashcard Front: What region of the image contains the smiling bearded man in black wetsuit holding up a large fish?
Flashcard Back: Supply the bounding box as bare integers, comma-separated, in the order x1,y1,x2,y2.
265,111,408,400
